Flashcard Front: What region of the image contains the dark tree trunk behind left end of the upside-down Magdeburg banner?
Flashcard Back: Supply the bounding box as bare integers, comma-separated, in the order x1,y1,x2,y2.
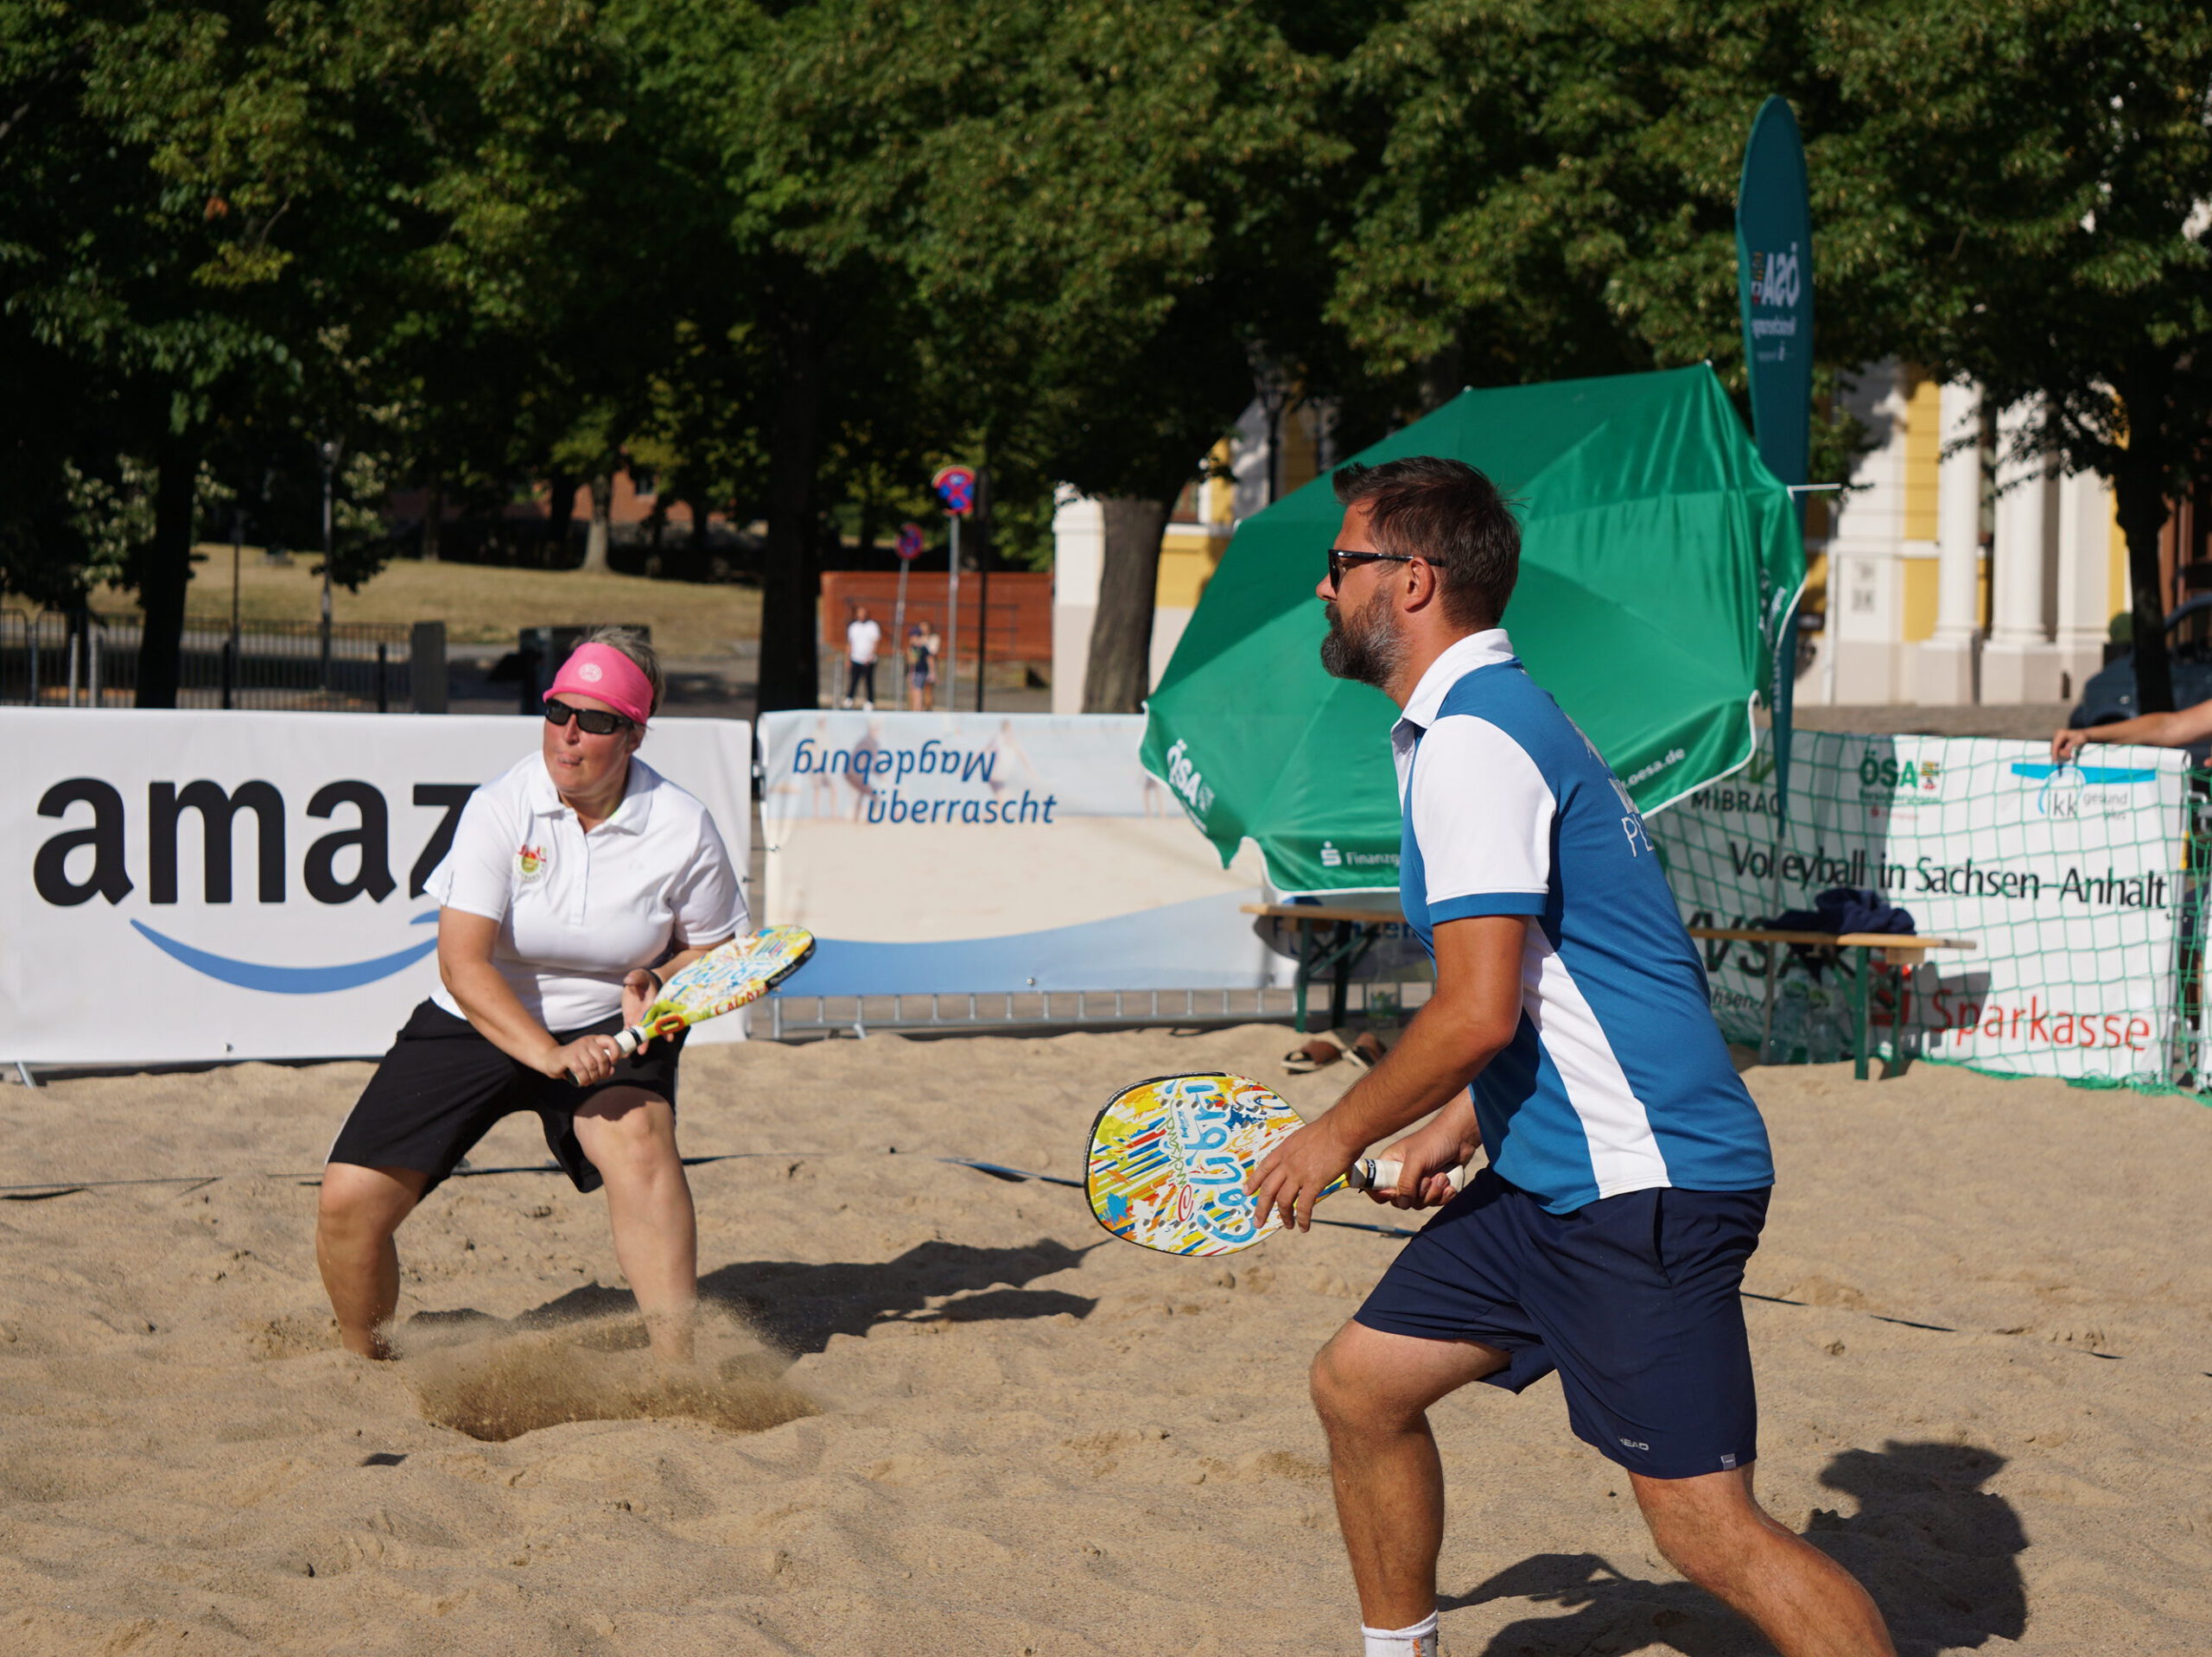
759,323,823,713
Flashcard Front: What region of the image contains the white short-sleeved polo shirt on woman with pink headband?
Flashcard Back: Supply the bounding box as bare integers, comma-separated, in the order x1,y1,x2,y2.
427,754,750,1031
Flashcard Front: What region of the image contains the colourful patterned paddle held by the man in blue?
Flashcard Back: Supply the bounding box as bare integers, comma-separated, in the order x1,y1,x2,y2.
1084,1073,1466,1254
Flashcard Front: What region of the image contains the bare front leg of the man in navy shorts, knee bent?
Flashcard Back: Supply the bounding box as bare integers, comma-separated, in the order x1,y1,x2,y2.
1312,1323,1506,1628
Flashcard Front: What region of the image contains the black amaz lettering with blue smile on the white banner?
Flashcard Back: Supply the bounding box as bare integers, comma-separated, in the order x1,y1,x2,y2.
31,777,480,995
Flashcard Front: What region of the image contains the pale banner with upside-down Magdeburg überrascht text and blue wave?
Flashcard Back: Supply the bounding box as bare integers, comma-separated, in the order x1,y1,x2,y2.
761,713,1269,995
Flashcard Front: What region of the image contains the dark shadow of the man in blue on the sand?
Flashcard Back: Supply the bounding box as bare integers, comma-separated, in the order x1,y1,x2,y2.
1440,1443,2029,1657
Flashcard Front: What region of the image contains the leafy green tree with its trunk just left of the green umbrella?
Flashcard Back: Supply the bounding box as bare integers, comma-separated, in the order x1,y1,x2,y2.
760,0,1343,710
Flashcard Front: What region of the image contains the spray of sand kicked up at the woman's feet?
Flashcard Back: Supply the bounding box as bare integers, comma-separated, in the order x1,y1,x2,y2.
398,1307,821,1443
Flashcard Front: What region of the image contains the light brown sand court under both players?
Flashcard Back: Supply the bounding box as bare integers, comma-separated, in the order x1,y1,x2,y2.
0,1026,2212,1657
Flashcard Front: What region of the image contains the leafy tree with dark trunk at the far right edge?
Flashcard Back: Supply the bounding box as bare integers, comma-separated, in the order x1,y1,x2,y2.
1832,0,2212,713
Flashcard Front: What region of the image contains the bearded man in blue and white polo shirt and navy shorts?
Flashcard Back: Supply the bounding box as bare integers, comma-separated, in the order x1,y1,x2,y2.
1252,458,1891,1657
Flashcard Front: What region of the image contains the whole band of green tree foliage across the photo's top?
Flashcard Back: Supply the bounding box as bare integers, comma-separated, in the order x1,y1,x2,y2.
0,0,2212,708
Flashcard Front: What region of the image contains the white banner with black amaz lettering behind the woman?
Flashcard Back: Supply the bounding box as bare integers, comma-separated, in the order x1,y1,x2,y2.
0,708,752,1064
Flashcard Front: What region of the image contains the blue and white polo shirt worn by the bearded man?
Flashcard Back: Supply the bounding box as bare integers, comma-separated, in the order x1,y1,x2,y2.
1391,628,1774,1215
